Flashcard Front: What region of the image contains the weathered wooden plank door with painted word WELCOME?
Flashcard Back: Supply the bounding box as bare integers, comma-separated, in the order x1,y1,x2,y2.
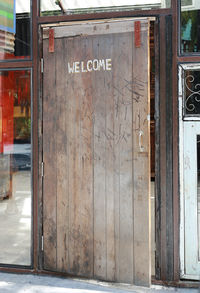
43,19,151,285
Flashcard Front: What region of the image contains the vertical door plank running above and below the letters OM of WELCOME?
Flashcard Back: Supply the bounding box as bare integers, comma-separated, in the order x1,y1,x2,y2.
92,33,109,279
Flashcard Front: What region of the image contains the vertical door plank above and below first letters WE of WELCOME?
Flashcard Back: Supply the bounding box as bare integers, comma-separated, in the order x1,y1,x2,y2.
66,38,83,275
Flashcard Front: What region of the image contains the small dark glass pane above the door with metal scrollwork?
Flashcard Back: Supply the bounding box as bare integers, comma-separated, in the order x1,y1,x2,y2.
181,0,200,53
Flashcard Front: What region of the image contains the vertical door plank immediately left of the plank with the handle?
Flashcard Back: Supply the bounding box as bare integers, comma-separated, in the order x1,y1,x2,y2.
113,33,133,283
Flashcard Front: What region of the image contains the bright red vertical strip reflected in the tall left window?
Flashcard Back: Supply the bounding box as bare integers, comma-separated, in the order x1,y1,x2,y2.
0,71,14,153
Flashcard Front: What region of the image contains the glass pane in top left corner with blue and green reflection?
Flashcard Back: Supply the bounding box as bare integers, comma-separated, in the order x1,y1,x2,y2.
0,0,31,60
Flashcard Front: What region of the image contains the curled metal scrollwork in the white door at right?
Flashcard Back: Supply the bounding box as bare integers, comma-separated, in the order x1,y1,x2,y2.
185,74,200,114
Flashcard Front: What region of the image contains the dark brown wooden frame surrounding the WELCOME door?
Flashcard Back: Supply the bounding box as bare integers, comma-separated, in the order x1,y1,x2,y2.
38,14,179,282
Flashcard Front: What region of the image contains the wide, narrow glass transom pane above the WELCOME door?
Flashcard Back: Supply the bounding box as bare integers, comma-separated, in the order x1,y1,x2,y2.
40,0,171,15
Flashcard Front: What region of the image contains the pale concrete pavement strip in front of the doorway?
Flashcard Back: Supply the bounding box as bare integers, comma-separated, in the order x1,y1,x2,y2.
0,273,199,293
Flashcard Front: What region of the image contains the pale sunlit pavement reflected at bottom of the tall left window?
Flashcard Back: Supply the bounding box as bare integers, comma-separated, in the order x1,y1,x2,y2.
0,171,31,265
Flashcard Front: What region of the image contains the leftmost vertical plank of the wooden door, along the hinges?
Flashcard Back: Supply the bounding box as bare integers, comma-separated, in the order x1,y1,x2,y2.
43,41,57,270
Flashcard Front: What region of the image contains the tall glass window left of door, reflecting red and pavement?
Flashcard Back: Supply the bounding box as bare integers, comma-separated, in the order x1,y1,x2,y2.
0,70,32,266
